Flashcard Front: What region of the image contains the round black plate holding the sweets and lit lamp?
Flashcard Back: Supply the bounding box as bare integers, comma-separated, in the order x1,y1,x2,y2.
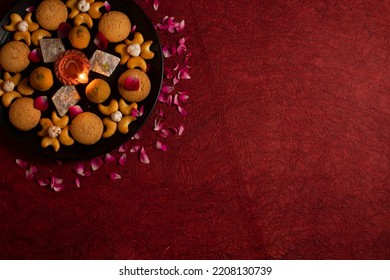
0,0,164,160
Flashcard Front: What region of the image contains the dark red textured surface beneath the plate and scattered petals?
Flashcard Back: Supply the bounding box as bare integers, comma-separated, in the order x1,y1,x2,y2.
0,0,390,259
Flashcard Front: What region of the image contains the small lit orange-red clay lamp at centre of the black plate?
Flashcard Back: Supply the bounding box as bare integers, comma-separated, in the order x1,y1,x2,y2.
54,50,90,86
